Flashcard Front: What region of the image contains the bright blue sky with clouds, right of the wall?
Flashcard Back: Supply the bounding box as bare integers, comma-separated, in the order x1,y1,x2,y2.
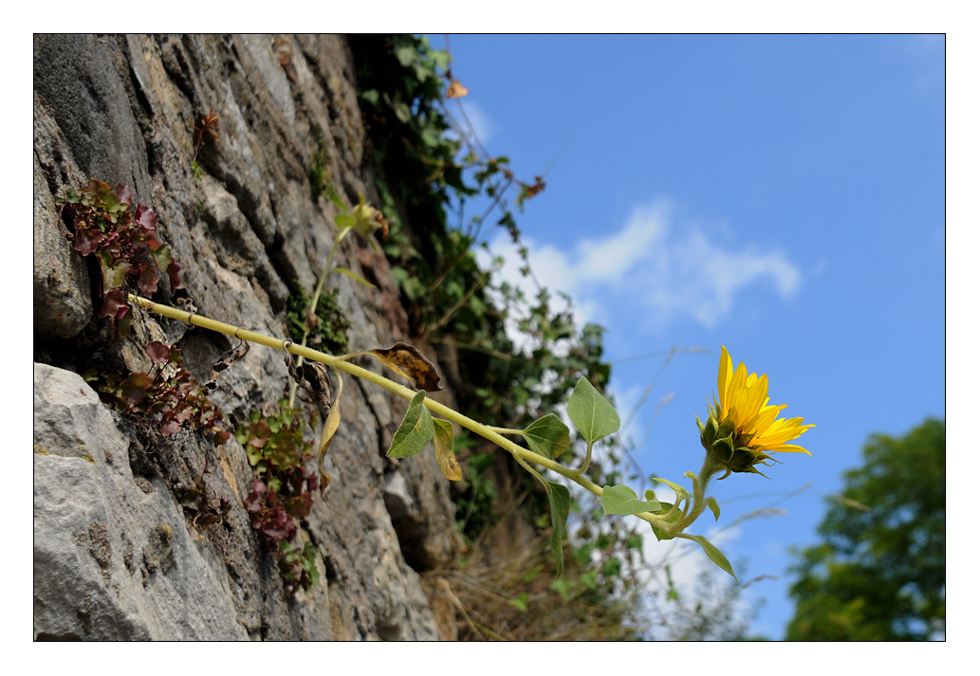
440,35,946,639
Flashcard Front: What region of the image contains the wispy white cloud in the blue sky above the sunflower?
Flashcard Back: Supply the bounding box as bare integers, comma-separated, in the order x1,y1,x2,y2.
484,199,801,327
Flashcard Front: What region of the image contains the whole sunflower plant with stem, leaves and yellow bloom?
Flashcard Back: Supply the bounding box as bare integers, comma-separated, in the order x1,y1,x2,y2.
130,296,812,577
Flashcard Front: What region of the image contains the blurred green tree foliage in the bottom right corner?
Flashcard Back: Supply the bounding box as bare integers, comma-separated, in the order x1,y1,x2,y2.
787,419,946,641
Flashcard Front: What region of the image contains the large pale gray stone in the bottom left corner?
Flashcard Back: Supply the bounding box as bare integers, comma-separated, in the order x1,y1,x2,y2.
34,364,248,640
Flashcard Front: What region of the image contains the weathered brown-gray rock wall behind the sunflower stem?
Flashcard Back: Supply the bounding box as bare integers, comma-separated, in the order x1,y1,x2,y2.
34,35,459,640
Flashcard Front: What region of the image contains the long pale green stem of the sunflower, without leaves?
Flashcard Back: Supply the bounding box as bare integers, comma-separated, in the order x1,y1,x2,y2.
129,294,692,534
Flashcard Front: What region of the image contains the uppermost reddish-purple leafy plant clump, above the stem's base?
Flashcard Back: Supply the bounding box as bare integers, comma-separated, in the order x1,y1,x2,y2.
58,179,181,340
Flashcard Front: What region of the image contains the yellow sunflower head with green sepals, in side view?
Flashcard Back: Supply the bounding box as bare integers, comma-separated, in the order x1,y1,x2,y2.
698,346,814,478
